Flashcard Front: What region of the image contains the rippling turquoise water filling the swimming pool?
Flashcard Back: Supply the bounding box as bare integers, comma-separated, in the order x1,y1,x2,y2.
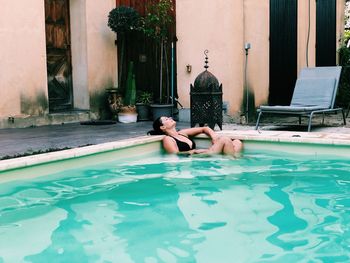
0,152,350,263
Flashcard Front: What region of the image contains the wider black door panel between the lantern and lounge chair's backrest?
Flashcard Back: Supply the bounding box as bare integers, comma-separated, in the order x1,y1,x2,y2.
269,0,297,105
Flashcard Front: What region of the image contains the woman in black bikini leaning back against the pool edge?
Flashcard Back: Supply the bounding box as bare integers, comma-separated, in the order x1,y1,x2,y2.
150,116,243,156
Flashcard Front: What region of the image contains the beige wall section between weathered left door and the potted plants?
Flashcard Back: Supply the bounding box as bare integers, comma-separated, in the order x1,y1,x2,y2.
70,0,117,109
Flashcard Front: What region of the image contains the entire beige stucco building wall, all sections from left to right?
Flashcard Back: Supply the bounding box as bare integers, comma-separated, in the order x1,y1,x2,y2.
0,0,345,126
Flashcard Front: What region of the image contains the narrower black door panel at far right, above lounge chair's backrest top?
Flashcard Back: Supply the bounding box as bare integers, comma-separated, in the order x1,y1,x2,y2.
316,0,337,66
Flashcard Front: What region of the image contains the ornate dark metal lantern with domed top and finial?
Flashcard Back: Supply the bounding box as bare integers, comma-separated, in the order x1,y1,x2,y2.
190,50,222,130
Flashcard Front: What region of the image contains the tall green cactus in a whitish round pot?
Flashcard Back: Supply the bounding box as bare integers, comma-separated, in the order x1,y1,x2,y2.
118,61,137,123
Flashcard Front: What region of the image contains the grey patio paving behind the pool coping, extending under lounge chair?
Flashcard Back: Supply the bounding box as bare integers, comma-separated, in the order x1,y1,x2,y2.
0,110,350,159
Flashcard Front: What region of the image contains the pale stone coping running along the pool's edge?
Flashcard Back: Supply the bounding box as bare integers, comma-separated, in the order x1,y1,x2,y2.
0,130,350,172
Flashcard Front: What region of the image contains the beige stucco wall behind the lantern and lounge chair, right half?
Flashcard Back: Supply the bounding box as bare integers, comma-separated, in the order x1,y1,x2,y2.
176,0,344,115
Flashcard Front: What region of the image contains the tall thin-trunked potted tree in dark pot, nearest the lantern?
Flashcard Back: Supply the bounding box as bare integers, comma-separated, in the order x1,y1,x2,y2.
141,0,173,120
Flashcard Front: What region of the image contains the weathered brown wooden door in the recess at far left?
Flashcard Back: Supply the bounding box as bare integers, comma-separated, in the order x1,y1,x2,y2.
45,0,73,112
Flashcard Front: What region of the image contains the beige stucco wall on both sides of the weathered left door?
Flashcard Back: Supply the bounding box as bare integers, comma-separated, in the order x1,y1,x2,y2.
0,0,117,124
